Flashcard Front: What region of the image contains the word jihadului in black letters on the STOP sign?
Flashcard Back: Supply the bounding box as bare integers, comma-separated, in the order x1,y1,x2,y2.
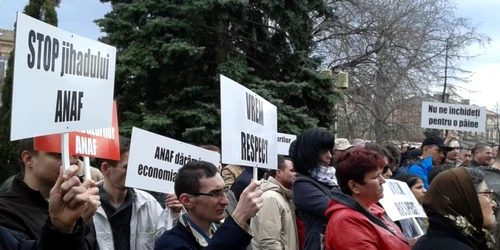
61,41,109,79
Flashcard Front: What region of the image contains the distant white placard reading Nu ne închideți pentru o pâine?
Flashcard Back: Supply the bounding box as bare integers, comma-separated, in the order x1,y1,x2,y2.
421,102,486,132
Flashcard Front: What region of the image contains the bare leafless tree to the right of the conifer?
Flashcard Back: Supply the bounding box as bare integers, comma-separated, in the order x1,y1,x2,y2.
316,0,489,141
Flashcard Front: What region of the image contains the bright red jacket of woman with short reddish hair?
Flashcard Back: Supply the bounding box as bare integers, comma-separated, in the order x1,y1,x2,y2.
325,200,410,250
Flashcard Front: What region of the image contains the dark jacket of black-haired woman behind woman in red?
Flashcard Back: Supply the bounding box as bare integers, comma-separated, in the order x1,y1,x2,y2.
292,174,340,250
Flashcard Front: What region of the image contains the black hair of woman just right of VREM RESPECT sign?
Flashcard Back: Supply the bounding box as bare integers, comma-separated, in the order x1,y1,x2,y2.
290,128,335,176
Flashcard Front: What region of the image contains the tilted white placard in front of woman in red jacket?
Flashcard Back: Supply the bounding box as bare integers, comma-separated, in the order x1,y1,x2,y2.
380,180,427,221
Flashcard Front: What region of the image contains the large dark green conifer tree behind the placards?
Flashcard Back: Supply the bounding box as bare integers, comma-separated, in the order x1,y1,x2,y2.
96,0,337,144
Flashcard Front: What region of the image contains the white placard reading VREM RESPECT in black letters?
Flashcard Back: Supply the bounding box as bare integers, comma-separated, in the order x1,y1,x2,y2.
220,75,278,169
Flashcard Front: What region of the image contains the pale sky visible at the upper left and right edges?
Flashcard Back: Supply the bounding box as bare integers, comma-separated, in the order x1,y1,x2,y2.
0,0,500,110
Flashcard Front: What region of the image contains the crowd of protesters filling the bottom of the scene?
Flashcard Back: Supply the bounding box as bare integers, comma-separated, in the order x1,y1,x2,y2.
0,129,500,250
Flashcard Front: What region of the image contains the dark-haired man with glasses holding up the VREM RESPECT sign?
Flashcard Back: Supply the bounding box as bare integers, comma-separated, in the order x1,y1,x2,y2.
155,161,262,250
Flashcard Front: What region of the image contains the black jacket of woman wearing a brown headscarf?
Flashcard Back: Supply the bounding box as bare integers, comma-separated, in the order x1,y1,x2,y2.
412,215,476,250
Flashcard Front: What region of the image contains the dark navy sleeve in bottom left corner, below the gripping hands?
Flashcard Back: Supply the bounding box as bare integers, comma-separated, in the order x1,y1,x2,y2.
0,219,88,250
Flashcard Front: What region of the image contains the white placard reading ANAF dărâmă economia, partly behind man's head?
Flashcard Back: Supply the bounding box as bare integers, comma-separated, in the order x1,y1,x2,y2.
125,127,220,194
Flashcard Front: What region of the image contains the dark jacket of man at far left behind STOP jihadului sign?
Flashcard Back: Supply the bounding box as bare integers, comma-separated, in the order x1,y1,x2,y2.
0,175,99,250
